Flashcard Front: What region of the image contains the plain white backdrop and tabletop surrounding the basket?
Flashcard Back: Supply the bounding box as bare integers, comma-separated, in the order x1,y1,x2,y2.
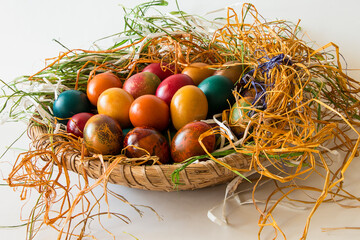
0,0,360,240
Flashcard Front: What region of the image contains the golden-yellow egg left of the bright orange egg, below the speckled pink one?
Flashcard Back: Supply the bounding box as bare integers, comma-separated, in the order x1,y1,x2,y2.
97,88,134,128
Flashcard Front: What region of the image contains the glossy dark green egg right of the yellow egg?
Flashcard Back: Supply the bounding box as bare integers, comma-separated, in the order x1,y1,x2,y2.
198,75,234,117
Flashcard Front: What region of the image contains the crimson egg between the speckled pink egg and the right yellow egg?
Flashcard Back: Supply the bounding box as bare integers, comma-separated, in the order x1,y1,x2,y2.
156,74,194,105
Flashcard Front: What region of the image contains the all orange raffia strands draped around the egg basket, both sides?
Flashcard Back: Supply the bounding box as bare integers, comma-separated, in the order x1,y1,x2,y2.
5,4,360,239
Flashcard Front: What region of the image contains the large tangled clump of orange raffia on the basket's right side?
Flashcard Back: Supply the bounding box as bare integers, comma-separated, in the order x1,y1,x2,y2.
199,2,360,239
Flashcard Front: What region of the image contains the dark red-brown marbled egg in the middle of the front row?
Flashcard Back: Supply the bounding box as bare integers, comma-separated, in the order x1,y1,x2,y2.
124,127,170,163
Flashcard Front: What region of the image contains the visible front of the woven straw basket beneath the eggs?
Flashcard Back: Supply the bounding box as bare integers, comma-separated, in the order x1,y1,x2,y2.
28,123,251,192
